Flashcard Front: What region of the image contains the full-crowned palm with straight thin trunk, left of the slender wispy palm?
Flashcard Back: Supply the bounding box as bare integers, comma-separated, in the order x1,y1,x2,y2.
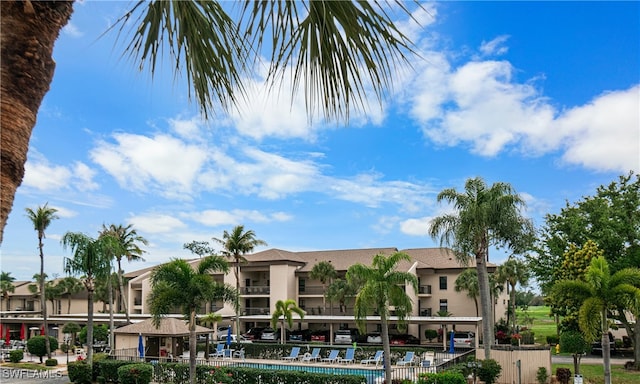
60,232,118,364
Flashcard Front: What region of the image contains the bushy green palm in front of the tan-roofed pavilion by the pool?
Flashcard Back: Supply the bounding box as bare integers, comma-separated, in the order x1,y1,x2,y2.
149,256,237,384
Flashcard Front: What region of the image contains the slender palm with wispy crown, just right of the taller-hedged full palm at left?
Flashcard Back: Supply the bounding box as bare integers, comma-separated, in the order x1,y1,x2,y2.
101,224,149,324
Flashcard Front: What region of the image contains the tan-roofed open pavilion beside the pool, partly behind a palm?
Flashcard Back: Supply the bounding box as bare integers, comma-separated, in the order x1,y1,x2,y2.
114,317,213,358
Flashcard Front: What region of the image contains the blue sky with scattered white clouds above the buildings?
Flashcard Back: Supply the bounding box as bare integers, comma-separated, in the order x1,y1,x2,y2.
1,1,640,280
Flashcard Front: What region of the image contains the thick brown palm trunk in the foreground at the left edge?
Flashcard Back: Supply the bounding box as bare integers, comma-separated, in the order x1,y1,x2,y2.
0,1,73,243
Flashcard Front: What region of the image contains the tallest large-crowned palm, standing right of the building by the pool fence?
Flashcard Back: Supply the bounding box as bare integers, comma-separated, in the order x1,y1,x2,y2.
429,177,533,359
